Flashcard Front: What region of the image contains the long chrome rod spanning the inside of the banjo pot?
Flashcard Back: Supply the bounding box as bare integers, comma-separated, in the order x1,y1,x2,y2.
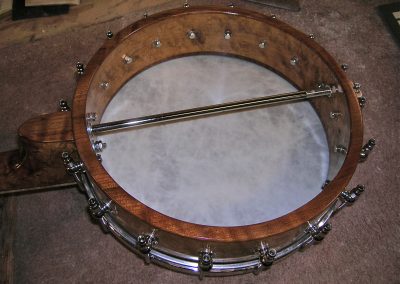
90,88,333,134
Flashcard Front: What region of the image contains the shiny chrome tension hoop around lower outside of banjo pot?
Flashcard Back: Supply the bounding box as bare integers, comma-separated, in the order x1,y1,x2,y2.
75,165,344,278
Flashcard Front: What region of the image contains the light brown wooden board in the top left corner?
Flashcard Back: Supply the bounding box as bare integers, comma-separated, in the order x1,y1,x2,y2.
0,0,178,48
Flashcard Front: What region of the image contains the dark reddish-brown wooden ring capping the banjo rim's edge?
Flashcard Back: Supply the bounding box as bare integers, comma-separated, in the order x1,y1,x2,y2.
73,7,363,242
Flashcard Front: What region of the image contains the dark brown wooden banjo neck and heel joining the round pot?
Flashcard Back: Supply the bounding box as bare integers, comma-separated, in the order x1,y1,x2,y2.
0,112,75,195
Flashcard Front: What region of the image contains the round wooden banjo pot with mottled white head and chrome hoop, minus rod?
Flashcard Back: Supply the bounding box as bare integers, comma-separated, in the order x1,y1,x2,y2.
72,7,363,274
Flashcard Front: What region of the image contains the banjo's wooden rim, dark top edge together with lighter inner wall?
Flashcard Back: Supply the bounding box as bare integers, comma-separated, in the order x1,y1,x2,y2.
72,7,363,251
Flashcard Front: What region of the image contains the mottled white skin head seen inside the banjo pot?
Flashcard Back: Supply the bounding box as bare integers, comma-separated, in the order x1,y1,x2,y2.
100,55,329,226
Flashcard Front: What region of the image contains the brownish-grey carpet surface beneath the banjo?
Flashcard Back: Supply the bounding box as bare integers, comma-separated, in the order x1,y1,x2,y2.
0,0,400,283
